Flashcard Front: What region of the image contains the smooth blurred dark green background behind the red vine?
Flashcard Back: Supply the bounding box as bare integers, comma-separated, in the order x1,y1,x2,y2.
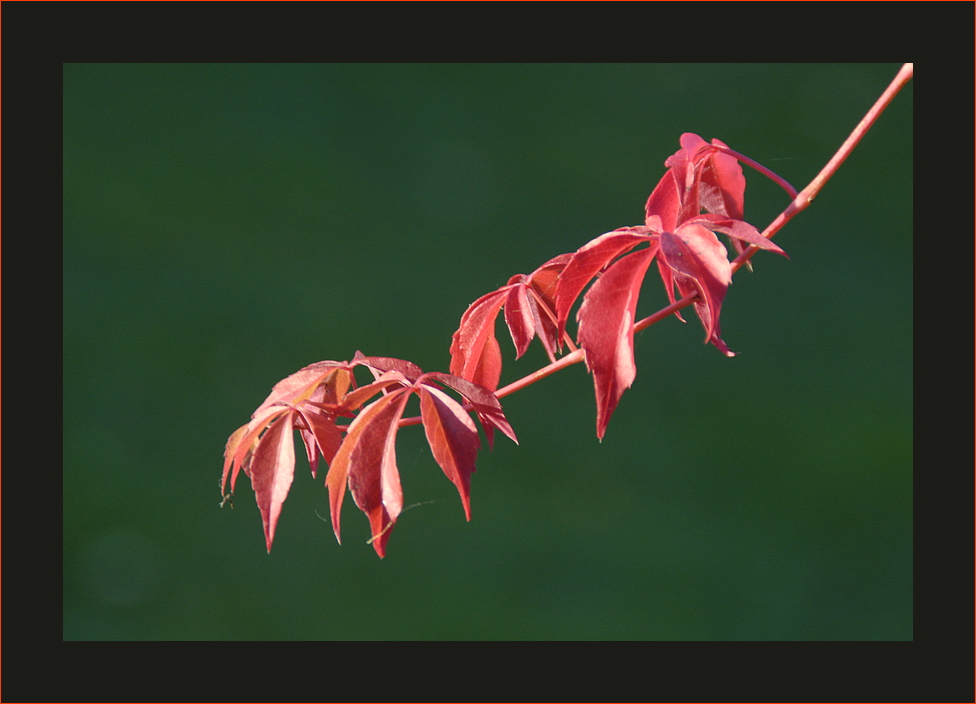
63,64,913,640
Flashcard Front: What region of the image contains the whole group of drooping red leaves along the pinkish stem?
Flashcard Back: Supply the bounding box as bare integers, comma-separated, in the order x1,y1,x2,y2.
221,133,796,557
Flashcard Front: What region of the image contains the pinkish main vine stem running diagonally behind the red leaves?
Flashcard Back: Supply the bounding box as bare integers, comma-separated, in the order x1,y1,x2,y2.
400,63,915,426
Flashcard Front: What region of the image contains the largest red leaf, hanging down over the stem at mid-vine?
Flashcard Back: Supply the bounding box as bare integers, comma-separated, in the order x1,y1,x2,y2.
567,244,658,439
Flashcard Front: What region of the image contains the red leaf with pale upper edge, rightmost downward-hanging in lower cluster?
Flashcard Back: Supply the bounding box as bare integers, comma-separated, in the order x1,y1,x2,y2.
419,384,481,521
